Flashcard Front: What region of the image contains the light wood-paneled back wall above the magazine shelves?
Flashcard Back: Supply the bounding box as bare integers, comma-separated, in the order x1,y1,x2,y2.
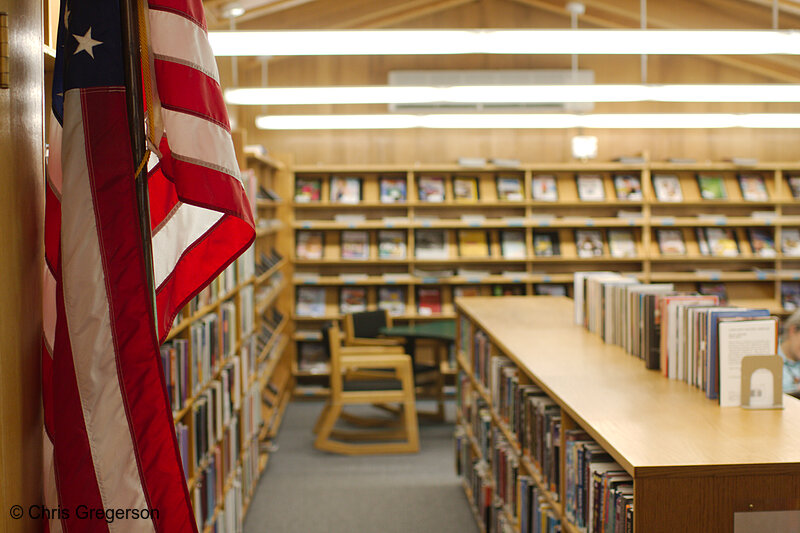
220,0,800,164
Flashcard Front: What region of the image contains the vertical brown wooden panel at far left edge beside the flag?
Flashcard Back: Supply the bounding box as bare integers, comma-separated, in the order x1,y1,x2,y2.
0,0,44,533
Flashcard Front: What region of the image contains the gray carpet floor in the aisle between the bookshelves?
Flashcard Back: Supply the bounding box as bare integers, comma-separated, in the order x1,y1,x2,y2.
244,402,478,533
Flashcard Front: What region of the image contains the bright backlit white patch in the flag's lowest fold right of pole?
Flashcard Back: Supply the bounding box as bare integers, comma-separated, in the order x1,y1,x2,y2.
153,203,222,287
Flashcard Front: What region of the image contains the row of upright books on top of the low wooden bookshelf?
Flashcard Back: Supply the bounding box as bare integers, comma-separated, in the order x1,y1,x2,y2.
575,272,779,406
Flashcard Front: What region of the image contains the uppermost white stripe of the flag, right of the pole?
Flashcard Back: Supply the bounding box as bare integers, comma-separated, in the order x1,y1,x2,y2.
150,9,219,83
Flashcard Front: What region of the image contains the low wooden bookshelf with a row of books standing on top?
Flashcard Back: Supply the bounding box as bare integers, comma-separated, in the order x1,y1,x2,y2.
456,296,800,533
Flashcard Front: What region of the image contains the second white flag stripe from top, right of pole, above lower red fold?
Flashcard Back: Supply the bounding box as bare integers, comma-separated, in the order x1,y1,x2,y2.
161,108,240,179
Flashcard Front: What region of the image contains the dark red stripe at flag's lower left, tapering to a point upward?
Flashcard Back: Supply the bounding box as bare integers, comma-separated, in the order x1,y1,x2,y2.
52,256,108,533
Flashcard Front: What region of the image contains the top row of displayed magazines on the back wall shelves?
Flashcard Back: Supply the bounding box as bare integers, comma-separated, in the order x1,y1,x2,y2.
294,173,800,204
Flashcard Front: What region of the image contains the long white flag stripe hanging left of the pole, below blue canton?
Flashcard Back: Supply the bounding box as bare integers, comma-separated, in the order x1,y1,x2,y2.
61,89,154,533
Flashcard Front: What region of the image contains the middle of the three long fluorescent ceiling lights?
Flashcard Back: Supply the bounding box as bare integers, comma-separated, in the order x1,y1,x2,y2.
225,84,800,105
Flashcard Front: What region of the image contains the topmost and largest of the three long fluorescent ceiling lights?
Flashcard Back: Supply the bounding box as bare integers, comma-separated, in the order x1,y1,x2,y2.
209,30,800,56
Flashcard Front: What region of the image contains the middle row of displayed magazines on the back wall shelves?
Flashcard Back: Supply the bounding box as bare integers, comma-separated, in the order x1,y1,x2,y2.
295,226,800,261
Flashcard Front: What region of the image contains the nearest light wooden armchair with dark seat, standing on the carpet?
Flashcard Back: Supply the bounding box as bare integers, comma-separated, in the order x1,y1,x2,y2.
314,324,419,455
